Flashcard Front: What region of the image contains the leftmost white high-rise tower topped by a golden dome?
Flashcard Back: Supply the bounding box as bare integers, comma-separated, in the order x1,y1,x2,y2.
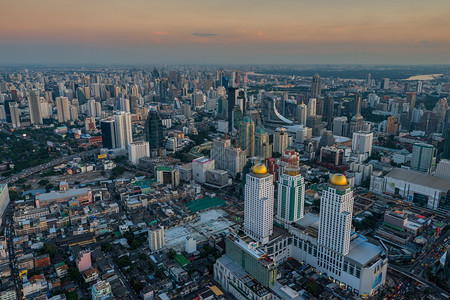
244,165,274,244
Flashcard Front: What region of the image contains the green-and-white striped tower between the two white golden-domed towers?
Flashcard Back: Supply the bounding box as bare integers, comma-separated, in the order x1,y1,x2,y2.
276,166,305,224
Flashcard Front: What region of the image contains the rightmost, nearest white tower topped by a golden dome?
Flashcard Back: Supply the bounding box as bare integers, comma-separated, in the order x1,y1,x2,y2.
318,174,353,276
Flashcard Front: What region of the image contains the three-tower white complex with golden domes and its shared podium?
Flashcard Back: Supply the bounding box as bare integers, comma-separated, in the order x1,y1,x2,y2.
215,163,387,299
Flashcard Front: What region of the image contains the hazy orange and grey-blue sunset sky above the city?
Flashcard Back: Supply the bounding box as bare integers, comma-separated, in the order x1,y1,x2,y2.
0,0,450,64
